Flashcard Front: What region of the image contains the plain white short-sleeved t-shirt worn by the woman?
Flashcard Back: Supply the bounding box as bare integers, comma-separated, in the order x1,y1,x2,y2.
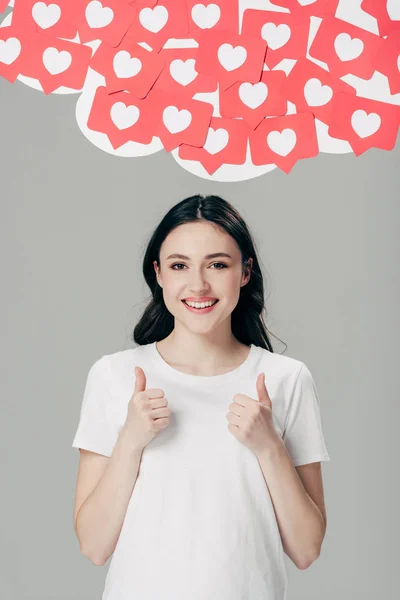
72,343,330,600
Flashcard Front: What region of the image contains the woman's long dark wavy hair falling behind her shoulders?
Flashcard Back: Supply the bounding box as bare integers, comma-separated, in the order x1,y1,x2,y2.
132,194,287,352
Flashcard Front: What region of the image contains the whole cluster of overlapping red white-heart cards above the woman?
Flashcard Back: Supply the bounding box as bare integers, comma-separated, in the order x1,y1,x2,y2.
0,0,400,174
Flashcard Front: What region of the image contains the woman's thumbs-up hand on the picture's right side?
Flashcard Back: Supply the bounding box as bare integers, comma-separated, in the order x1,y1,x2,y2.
226,373,281,455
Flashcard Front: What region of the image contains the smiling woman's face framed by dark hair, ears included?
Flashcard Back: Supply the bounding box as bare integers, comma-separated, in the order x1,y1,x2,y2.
154,221,252,333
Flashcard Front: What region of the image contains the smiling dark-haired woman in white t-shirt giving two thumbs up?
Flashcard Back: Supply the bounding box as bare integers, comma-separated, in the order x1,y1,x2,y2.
72,195,330,600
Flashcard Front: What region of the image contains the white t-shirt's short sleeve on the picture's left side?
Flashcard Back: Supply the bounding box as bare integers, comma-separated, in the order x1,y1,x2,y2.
72,356,118,456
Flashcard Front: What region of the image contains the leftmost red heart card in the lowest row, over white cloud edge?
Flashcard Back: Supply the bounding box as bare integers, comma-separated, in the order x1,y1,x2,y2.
87,86,153,149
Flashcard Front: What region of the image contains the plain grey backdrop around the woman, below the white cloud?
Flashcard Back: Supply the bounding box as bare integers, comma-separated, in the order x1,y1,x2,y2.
0,68,400,600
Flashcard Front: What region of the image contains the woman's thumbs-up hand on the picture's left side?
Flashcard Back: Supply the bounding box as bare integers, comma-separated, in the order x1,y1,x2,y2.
126,367,171,449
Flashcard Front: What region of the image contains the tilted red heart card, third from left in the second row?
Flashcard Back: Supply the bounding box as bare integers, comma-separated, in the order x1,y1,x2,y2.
90,38,165,98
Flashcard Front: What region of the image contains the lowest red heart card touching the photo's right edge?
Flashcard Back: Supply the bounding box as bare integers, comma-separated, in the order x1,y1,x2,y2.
328,94,400,156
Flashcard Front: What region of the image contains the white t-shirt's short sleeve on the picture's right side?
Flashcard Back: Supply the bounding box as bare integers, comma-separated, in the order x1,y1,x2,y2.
282,363,330,467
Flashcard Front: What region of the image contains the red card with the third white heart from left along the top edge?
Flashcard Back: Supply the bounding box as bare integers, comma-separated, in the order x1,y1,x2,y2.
126,0,189,52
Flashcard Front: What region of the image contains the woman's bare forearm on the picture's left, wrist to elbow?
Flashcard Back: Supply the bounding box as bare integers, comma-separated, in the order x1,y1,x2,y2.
75,425,143,566
